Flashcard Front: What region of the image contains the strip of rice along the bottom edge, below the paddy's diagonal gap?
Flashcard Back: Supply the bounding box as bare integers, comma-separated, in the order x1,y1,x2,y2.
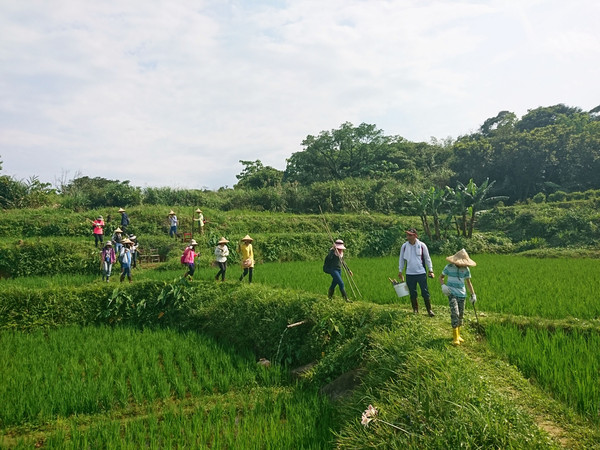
17,388,335,449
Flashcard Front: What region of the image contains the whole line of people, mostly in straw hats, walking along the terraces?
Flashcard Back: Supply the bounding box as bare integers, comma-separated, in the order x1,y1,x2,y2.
93,208,477,345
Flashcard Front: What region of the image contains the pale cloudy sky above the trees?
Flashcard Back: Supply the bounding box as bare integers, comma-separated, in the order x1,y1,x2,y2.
0,0,600,189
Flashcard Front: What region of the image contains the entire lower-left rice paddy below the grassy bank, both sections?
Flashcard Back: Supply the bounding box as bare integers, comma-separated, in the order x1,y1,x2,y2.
0,327,333,449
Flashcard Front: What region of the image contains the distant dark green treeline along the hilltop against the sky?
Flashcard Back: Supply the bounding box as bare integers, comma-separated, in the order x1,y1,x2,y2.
0,104,600,214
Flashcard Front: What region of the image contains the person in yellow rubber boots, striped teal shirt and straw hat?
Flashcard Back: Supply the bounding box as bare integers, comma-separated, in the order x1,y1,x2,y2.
440,248,477,345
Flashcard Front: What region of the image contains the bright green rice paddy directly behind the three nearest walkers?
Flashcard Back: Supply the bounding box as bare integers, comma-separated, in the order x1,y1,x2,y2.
251,255,600,319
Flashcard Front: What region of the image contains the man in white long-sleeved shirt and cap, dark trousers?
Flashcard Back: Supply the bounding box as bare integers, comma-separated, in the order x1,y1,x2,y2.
398,228,435,317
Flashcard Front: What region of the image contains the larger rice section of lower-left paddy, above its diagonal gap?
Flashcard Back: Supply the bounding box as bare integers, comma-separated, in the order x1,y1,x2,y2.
0,327,281,426
